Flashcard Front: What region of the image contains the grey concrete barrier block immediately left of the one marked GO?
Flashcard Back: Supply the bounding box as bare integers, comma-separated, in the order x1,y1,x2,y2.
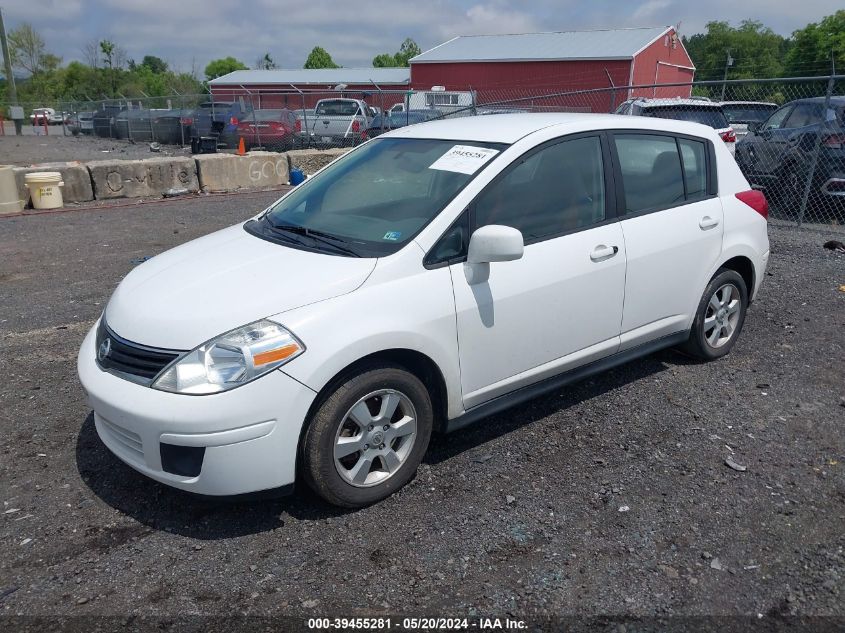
88,156,199,200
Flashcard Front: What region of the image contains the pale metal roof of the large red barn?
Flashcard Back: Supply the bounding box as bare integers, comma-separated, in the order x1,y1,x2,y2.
411,26,672,64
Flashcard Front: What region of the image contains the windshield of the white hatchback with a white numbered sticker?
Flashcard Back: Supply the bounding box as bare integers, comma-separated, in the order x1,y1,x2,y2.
245,138,506,257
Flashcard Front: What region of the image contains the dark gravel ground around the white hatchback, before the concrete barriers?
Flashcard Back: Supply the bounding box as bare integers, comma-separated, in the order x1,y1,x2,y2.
0,195,845,630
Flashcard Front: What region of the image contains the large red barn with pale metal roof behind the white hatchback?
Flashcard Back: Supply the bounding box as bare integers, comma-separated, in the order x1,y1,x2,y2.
411,27,695,112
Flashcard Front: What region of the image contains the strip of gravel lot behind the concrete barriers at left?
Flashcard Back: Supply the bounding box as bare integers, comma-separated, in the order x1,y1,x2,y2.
0,131,191,166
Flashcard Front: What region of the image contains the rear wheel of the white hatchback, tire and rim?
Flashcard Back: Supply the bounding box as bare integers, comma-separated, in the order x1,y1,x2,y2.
681,268,748,361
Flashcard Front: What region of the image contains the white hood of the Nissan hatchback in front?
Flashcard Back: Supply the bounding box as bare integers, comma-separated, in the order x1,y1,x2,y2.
105,225,377,350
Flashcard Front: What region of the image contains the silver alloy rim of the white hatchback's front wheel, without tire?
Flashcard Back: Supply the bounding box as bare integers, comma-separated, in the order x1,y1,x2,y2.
333,389,417,488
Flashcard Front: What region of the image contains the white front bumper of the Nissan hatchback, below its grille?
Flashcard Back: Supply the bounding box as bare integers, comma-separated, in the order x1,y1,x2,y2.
77,324,316,496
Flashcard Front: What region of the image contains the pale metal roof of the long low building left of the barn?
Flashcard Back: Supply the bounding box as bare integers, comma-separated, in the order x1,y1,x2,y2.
209,68,411,86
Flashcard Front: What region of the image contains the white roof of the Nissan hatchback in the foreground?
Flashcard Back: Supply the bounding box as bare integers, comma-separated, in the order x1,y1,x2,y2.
382,112,714,144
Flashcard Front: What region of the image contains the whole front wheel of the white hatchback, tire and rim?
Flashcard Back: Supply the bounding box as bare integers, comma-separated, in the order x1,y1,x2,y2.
302,366,434,508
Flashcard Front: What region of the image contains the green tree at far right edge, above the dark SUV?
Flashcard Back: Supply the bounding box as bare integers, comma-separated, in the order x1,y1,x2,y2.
786,10,845,76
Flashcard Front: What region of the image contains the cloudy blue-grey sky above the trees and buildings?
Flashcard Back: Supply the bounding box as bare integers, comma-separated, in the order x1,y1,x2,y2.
0,0,842,77
